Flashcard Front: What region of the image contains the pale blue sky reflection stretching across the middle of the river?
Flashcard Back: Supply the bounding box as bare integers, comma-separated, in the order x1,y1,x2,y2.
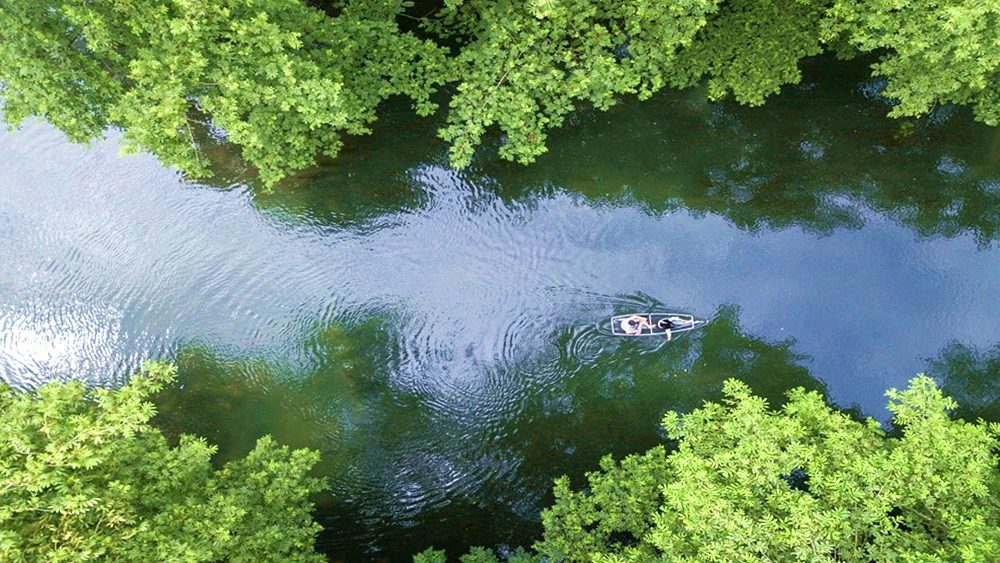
0,126,1000,414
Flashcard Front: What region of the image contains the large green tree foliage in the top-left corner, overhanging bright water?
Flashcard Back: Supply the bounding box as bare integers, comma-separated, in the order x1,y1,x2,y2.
0,0,443,184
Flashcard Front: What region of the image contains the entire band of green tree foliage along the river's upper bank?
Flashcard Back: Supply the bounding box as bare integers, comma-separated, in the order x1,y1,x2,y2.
0,0,1000,185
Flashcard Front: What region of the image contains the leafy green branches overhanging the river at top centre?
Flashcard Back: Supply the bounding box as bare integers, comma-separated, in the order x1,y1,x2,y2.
431,0,718,166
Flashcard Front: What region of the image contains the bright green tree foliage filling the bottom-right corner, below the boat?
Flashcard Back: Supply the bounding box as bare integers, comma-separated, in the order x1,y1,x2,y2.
536,376,1000,562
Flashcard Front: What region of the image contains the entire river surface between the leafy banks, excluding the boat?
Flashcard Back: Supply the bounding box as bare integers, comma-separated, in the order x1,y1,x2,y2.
0,63,1000,560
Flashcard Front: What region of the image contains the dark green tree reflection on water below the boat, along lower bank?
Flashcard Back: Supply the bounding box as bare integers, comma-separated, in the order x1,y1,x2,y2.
157,306,825,560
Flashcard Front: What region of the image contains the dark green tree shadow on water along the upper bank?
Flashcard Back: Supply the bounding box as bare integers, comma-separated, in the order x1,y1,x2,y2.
238,57,1000,245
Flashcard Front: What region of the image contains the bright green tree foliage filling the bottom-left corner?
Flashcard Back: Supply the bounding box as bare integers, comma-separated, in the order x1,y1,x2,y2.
0,363,322,562
